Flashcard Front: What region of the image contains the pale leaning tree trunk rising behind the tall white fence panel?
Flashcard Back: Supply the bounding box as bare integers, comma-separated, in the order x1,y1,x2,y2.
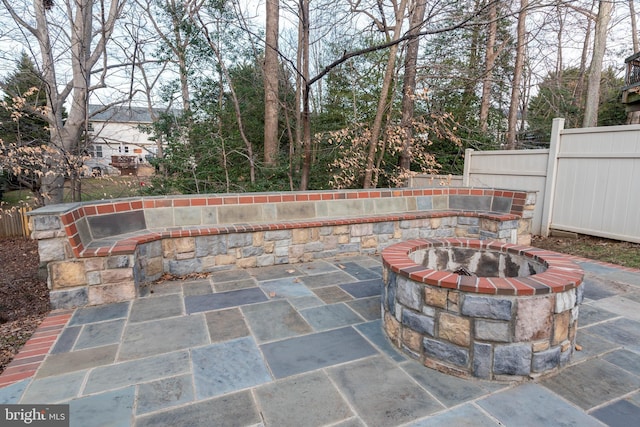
582,0,613,127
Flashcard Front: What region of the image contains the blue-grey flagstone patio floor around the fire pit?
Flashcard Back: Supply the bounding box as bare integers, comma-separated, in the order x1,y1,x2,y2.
0,256,640,427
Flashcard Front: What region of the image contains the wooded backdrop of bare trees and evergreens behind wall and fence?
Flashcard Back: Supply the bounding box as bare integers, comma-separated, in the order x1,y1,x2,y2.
0,0,640,204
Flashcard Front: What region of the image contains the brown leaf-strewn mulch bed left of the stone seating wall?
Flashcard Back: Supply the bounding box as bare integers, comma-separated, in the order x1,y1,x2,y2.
0,238,49,373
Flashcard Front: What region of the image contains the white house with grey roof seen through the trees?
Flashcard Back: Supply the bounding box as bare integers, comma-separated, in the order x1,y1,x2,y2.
85,104,175,175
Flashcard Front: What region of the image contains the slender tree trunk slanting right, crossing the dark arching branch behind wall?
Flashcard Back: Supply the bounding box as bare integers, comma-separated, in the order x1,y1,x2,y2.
362,0,407,188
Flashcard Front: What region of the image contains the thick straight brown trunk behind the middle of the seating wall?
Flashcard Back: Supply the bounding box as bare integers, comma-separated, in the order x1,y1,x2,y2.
263,0,280,166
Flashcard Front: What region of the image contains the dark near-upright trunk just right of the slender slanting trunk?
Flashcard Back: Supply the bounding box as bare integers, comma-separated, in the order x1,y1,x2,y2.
400,0,427,171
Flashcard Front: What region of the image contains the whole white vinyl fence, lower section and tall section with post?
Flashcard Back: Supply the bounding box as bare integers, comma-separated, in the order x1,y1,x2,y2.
413,119,640,243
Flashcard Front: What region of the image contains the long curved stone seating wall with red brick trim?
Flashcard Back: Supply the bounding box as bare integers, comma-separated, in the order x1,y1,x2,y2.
30,188,535,308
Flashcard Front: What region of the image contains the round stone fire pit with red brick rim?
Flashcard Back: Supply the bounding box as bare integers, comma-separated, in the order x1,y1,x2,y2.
382,239,584,379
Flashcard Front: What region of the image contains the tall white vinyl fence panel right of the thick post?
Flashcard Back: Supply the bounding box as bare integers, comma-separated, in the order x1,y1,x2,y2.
549,125,640,242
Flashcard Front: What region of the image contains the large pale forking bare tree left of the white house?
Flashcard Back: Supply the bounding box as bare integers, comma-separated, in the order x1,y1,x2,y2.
1,0,125,204
